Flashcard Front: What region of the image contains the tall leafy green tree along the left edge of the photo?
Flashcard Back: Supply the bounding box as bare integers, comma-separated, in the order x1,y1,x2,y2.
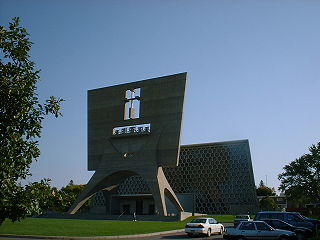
0,18,63,225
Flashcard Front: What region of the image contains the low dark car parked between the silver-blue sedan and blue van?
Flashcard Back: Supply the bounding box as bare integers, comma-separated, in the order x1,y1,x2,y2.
263,219,313,240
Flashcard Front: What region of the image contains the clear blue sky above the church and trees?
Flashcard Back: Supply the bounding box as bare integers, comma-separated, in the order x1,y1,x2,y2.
0,0,320,191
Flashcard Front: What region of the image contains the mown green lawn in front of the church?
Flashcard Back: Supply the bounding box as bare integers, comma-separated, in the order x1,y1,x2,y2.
0,215,234,236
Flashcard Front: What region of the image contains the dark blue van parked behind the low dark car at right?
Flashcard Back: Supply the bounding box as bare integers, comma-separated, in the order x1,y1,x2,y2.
255,211,316,232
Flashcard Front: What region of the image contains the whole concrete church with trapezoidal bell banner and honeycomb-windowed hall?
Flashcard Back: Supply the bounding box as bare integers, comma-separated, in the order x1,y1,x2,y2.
69,73,257,216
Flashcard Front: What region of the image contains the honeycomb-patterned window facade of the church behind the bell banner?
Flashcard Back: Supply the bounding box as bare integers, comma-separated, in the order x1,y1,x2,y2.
92,140,258,214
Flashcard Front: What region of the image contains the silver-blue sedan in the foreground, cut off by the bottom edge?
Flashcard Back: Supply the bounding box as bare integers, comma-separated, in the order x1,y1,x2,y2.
223,221,296,240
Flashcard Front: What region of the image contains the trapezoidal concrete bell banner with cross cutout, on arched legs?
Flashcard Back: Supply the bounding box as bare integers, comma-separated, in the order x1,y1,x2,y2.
69,73,187,216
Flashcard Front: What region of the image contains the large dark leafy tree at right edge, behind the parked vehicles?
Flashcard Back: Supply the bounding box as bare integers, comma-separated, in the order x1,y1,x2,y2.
278,142,320,201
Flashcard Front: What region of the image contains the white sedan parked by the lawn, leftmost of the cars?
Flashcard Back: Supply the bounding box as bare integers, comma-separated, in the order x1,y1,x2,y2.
185,218,224,237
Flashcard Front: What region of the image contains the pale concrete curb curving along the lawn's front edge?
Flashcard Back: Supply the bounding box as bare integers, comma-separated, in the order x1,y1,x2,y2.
0,229,184,240
